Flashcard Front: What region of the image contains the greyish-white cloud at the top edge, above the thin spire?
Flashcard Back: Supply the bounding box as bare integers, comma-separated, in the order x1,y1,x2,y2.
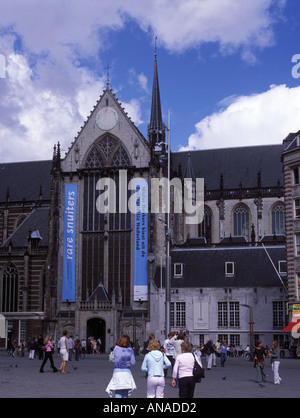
126,0,286,55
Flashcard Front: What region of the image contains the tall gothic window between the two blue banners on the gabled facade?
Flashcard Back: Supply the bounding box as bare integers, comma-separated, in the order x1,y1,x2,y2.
81,135,131,306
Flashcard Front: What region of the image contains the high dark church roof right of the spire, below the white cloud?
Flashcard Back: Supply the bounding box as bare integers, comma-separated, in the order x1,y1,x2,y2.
171,145,283,190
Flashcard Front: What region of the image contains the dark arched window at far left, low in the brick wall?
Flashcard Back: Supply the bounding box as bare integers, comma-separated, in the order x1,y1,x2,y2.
2,263,18,312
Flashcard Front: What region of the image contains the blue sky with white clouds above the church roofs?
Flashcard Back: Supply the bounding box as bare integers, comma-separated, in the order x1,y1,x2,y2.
0,0,300,162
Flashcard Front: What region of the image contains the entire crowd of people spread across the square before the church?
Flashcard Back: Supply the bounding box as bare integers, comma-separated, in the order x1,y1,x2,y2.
6,331,281,398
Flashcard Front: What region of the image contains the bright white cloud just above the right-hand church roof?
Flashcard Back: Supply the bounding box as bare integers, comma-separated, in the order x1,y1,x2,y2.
181,84,300,151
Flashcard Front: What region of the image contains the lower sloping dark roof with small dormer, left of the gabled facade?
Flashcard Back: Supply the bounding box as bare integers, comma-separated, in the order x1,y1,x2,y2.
2,208,49,247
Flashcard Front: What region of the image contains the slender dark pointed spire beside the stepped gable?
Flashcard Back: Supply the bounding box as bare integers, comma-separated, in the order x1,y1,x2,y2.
148,38,165,147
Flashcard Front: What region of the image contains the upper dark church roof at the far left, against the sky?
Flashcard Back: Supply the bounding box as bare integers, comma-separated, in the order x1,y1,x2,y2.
0,161,52,202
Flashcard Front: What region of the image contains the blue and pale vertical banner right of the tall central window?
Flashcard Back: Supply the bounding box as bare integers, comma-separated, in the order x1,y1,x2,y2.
134,178,148,301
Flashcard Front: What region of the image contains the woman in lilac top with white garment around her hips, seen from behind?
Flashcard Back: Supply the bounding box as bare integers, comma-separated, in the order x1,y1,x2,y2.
105,335,136,398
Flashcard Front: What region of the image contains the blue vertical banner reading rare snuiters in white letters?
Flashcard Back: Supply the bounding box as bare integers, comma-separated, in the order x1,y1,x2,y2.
62,184,77,302
